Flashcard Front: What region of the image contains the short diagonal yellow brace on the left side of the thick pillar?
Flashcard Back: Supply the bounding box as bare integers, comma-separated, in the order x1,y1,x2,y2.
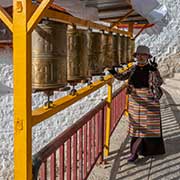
0,6,13,31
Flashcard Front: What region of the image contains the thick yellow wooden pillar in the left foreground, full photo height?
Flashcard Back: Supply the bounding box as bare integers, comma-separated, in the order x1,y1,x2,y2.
13,0,32,180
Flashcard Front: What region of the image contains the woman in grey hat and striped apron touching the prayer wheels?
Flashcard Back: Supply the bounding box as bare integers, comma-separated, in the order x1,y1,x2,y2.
109,46,165,162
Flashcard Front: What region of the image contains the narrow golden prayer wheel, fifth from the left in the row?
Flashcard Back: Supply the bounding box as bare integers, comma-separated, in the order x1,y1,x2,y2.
112,34,120,66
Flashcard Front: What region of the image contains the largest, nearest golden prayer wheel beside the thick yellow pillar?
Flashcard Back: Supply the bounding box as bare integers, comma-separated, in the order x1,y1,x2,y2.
32,20,67,90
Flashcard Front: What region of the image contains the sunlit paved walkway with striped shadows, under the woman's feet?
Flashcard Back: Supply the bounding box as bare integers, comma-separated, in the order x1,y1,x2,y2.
88,82,180,180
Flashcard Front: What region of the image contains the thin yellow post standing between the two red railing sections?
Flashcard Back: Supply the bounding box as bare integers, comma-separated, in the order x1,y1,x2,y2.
104,82,112,156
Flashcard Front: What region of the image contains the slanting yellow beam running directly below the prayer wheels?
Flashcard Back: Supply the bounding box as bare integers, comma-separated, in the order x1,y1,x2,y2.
32,75,112,126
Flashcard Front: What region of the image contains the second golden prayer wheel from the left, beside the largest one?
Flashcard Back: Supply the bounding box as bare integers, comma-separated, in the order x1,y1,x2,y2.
67,28,90,82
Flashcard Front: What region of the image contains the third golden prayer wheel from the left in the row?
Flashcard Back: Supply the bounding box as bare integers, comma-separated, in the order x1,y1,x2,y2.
89,32,104,75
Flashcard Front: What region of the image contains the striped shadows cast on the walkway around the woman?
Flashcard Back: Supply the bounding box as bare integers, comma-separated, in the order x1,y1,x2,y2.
107,90,180,180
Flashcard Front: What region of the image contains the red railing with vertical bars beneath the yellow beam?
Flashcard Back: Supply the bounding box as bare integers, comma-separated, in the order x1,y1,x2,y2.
33,87,126,180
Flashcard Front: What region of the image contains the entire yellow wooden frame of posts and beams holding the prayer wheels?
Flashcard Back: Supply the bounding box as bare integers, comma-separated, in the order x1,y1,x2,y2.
0,0,132,180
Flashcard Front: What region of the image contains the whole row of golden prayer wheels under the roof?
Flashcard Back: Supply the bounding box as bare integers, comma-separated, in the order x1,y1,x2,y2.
32,20,134,90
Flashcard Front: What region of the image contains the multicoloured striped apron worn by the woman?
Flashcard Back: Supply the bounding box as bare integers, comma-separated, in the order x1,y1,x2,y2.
129,88,161,137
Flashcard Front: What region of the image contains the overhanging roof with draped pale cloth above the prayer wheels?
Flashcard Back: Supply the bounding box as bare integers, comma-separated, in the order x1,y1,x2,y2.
0,0,168,39
